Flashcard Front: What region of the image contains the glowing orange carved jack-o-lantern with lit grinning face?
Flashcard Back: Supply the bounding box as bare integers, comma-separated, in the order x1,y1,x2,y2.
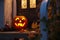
13,16,27,29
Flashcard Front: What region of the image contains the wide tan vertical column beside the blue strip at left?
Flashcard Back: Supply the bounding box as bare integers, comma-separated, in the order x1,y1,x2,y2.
4,0,12,26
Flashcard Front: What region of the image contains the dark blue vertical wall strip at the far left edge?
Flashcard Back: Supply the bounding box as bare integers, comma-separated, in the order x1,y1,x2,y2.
0,0,4,28
